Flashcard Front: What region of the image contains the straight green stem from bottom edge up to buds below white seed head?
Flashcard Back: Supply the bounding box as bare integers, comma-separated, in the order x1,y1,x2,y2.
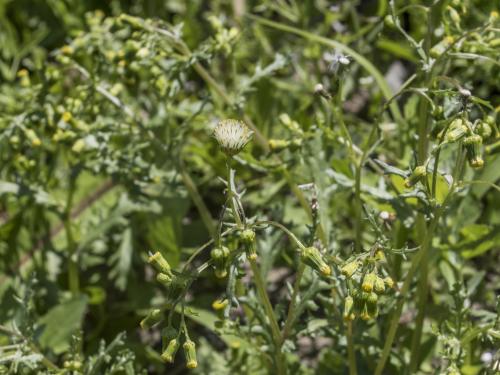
249,259,287,375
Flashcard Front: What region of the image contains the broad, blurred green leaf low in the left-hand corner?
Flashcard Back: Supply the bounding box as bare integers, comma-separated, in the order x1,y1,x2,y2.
39,295,88,354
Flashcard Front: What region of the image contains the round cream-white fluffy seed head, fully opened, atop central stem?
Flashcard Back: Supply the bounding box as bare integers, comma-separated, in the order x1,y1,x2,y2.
213,119,253,156
